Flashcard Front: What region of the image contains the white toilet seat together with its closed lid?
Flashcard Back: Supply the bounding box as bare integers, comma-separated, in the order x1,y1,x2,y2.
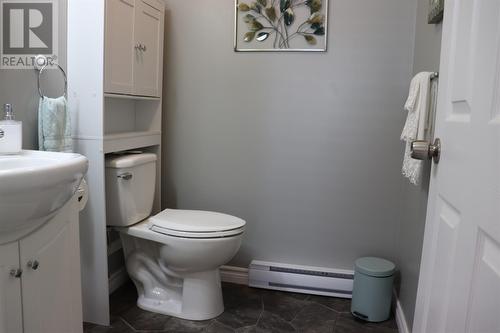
148,209,246,238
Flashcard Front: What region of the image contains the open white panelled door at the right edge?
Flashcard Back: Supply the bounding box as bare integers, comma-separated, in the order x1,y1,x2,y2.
413,0,500,333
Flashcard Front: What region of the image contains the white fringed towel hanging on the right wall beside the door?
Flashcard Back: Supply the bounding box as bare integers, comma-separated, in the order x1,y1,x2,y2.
401,72,432,185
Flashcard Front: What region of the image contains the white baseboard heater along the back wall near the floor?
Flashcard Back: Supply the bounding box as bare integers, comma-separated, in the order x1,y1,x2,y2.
248,260,354,298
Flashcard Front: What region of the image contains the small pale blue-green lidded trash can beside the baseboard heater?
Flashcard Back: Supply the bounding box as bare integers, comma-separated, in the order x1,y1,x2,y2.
351,257,396,322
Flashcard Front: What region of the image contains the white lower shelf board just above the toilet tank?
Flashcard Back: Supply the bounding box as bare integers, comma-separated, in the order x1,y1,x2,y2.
103,131,161,154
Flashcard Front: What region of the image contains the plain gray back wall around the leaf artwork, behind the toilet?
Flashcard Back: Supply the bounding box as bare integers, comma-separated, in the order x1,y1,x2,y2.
163,0,415,268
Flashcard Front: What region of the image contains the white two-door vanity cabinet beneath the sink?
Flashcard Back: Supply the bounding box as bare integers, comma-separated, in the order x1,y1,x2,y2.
0,198,83,333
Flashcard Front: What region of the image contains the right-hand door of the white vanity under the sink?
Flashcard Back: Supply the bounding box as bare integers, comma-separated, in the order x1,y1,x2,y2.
19,199,83,333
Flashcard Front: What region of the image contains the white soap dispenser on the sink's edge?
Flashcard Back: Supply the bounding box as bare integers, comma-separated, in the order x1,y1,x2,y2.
0,104,23,154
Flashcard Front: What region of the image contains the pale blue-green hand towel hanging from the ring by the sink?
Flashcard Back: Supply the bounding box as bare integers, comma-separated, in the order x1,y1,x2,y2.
38,96,73,153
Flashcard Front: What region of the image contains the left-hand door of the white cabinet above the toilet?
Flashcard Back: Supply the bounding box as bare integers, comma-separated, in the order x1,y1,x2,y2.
104,0,135,94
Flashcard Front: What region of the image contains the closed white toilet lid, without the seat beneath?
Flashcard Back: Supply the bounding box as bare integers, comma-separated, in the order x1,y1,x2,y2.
149,209,246,233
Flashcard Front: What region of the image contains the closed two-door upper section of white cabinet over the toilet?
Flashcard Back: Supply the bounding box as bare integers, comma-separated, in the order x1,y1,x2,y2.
104,0,164,97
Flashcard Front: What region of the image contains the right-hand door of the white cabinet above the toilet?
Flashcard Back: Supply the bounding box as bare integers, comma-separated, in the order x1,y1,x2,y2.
134,0,164,97
